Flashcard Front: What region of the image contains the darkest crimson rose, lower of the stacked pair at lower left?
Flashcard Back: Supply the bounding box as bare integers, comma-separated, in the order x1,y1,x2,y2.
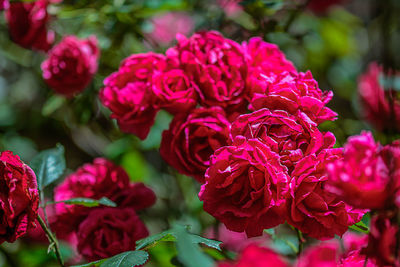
77,208,149,261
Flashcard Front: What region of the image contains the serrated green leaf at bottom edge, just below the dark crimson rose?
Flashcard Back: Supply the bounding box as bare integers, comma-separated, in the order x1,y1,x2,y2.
100,250,149,267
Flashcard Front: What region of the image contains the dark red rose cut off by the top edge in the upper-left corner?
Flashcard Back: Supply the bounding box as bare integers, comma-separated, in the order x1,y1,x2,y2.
6,0,55,51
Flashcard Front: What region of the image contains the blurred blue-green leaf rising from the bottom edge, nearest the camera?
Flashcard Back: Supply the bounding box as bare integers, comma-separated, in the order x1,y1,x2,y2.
174,225,214,267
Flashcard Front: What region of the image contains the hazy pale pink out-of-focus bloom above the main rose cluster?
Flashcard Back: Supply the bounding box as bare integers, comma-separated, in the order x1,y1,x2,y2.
148,12,194,46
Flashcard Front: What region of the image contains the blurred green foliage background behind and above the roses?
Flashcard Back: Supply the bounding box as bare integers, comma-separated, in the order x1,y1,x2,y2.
0,0,400,267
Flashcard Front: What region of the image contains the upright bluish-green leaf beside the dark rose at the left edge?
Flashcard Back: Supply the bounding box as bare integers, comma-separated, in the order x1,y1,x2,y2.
30,144,65,190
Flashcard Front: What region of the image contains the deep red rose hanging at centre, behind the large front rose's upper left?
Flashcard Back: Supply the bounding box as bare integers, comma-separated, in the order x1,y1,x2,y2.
160,107,230,183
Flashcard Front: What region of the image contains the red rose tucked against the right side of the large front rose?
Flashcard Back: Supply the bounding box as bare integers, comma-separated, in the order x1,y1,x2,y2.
287,149,364,240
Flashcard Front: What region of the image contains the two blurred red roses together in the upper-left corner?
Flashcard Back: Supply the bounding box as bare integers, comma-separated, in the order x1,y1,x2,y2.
0,0,100,97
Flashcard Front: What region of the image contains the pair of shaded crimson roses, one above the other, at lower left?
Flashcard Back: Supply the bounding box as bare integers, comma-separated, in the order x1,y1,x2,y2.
49,158,156,261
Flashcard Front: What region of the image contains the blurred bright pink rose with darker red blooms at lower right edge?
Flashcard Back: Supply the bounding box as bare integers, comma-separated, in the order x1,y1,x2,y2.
327,132,400,265
